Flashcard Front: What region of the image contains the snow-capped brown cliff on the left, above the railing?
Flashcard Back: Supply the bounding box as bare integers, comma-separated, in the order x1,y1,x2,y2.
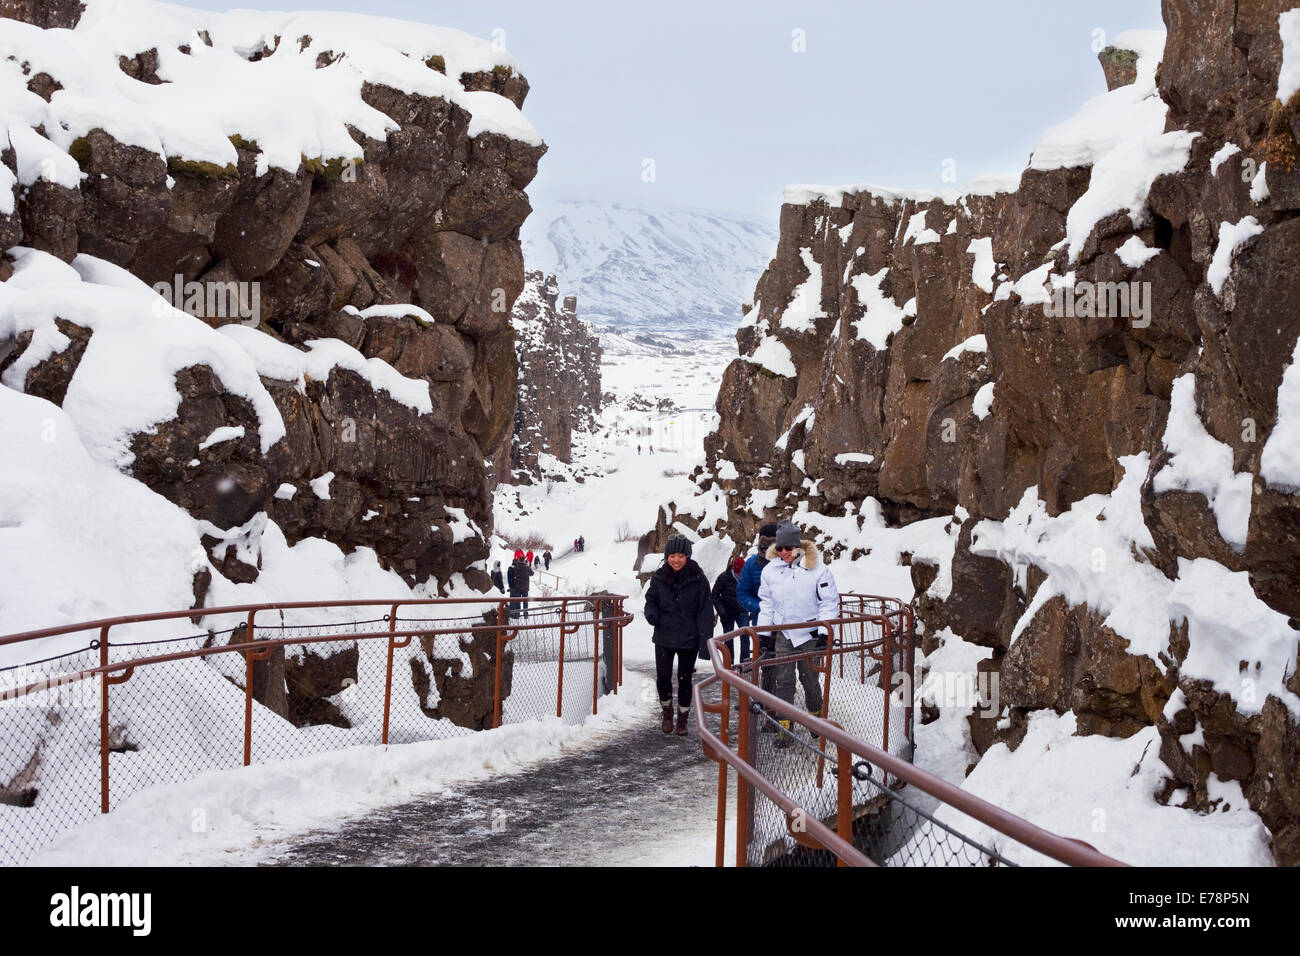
0,0,546,591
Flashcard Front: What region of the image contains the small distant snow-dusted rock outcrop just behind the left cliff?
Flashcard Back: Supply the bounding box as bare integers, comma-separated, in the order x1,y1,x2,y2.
502,271,601,481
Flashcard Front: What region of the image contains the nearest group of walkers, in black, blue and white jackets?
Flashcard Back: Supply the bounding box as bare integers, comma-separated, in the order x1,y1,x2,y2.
645,520,840,747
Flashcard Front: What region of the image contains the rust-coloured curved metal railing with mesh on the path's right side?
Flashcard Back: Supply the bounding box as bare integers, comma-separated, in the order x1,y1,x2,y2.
694,594,1123,866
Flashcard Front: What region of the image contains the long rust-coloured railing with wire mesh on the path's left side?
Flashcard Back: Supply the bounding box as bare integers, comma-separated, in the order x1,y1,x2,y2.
0,594,632,862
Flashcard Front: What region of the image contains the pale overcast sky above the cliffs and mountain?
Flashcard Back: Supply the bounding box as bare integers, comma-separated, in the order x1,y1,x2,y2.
182,0,1162,219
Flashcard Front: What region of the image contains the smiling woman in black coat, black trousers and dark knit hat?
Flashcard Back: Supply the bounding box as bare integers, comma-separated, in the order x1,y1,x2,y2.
645,536,714,736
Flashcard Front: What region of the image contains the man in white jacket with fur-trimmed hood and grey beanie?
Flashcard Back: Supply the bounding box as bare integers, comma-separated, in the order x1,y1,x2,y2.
758,522,840,744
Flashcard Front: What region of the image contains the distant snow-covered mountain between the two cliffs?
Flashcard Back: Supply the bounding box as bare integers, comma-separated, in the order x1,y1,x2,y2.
523,200,777,334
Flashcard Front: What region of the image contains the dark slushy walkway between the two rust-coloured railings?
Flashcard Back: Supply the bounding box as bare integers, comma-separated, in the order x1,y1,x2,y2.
267,665,738,866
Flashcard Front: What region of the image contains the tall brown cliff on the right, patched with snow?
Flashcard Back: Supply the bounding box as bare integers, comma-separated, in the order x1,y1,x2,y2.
697,0,1300,864
